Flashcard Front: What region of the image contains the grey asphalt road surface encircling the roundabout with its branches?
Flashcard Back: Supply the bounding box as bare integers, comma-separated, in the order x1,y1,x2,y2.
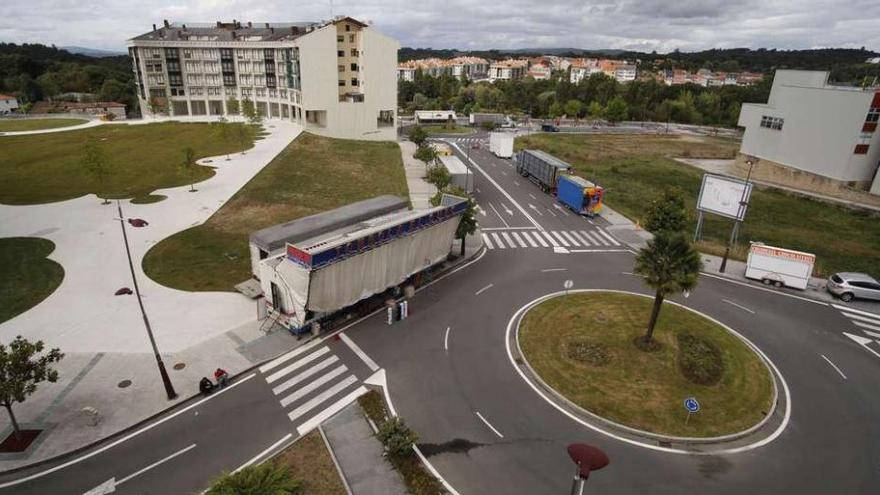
6,130,880,495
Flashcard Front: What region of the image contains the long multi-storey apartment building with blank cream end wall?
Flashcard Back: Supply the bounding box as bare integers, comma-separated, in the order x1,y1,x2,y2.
129,17,400,140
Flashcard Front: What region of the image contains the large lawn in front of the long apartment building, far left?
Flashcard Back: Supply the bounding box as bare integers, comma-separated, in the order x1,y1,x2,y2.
0,122,257,205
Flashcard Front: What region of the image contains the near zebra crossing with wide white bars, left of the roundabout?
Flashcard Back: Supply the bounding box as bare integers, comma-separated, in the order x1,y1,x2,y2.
260,335,375,435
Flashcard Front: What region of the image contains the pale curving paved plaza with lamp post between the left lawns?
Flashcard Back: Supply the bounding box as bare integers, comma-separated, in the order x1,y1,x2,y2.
0,121,301,470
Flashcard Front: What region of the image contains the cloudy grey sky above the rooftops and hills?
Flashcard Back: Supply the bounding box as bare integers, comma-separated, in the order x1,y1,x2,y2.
0,0,880,52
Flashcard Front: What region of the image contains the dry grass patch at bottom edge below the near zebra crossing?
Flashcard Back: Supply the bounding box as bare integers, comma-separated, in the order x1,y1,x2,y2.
271,430,345,495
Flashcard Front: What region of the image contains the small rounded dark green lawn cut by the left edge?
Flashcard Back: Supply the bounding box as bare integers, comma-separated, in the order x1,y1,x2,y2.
0,237,64,323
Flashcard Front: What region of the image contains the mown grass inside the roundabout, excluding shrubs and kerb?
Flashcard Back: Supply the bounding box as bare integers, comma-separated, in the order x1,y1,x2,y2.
519,292,773,437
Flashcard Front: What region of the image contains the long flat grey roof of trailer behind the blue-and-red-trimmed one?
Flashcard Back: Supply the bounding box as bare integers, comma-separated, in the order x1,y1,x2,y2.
250,195,409,252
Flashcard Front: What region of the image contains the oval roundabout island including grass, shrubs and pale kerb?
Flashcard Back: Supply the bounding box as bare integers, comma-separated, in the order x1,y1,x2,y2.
508,290,788,445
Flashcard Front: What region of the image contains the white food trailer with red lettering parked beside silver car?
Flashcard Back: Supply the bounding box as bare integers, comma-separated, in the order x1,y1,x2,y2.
746,242,816,290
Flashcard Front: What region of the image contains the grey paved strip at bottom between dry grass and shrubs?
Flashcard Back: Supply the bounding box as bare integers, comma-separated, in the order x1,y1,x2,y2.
322,402,407,495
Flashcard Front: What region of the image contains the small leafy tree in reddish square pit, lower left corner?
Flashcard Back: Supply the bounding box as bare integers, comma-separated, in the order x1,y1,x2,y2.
0,335,64,438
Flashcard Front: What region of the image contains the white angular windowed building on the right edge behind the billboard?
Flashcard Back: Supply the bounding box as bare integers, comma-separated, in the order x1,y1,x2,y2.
739,70,880,194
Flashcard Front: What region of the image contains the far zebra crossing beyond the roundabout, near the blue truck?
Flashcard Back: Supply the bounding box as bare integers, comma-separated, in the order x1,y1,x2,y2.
482,229,621,250
